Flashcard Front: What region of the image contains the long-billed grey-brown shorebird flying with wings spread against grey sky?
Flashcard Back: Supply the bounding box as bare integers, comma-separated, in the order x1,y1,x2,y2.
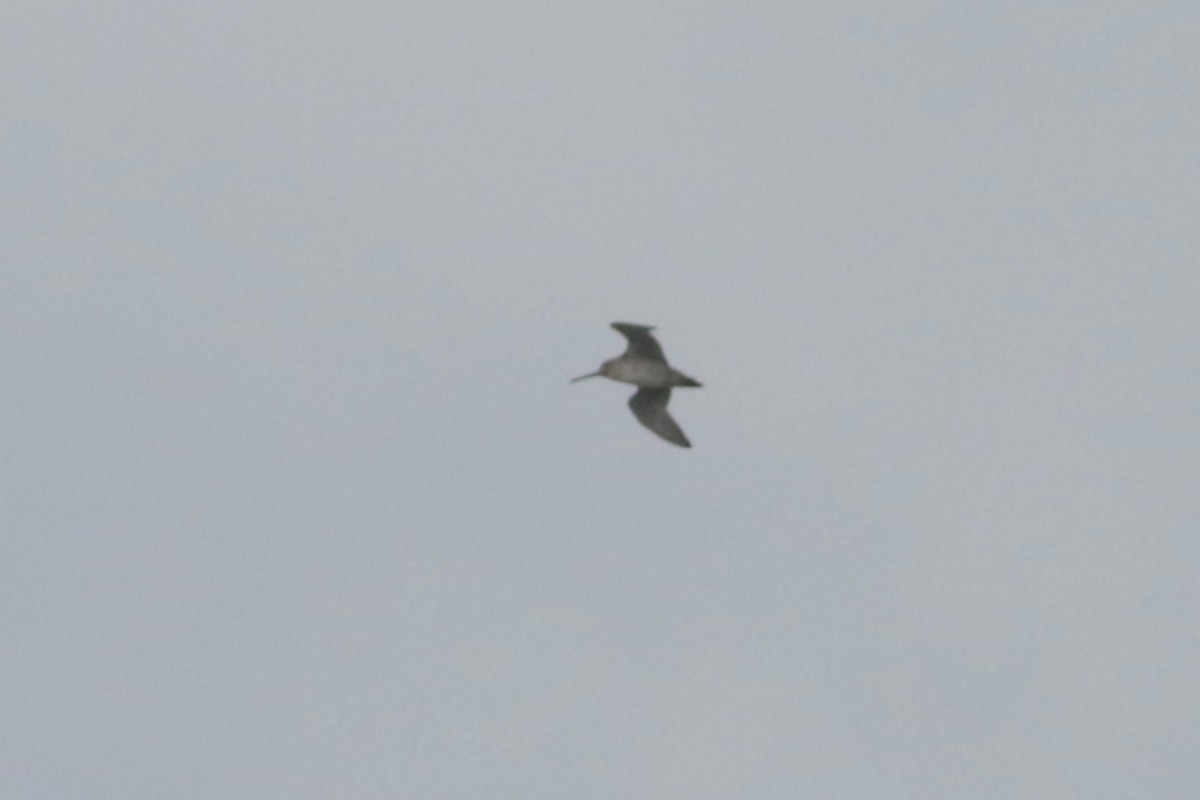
571,323,701,447
